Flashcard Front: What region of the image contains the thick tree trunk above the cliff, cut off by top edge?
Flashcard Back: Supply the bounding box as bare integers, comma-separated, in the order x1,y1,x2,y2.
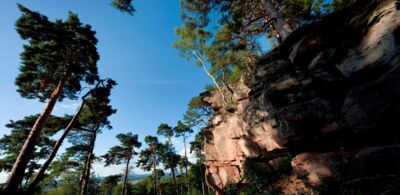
261,0,293,42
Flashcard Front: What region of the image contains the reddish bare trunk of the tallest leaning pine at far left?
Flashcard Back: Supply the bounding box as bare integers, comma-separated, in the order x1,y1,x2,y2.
3,72,69,194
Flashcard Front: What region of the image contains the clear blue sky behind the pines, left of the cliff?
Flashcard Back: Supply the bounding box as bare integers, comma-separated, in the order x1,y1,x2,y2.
0,0,209,182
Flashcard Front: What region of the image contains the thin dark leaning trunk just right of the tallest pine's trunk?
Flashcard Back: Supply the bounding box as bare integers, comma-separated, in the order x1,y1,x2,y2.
27,95,86,194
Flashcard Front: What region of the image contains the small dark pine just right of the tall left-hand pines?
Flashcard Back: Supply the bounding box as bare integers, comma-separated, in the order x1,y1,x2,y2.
102,132,142,195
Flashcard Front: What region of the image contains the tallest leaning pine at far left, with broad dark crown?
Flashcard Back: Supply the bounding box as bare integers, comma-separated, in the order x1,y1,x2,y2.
3,5,99,194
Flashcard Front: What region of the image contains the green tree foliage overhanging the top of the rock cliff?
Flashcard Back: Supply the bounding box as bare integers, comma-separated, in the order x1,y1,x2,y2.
174,0,354,87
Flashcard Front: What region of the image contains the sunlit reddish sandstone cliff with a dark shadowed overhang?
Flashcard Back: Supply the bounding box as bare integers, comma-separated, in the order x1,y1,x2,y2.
203,0,400,193
